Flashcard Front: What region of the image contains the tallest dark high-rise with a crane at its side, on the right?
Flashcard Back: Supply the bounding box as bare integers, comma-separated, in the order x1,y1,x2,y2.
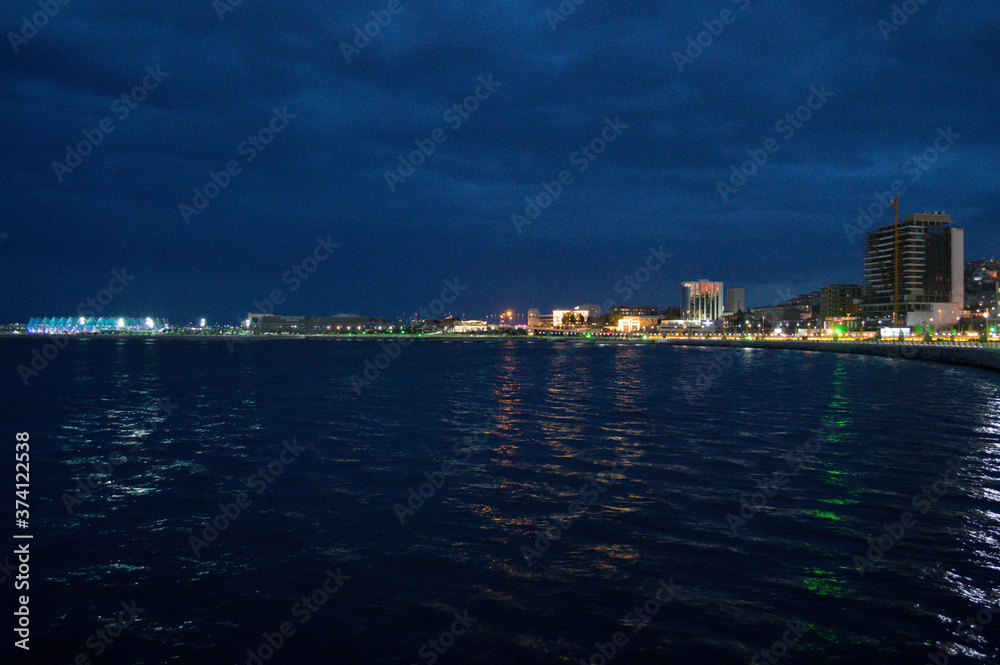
861,212,965,326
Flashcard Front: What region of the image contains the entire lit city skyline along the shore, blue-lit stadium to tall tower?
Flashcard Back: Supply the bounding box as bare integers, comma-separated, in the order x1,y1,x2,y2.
9,212,988,336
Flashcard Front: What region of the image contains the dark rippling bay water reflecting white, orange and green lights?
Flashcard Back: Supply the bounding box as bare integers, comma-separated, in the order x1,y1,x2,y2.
0,338,1000,665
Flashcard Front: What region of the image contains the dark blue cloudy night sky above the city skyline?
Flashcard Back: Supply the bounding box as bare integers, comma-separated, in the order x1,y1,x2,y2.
0,0,1000,323
